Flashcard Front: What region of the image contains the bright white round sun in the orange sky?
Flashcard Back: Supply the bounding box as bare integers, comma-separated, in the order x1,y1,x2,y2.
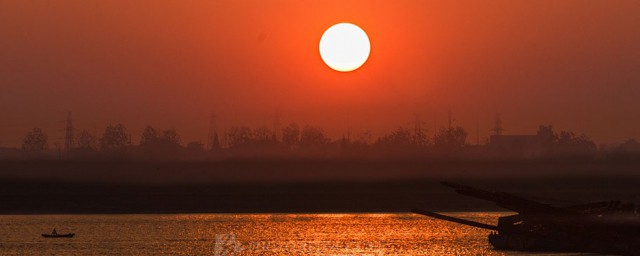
320,23,371,72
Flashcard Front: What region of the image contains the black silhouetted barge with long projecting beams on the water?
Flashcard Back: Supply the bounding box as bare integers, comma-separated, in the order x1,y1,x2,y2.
412,182,640,256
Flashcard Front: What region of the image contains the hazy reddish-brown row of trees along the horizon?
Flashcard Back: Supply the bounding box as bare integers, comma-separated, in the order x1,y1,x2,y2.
11,123,640,160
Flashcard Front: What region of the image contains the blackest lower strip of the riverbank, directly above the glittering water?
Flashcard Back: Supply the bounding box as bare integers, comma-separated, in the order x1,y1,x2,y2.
0,178,640,215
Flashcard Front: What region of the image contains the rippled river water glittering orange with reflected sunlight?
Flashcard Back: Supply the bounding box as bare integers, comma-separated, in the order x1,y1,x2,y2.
0,212,596,255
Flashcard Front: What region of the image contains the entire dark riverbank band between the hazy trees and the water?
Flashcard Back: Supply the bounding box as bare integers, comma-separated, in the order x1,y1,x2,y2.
0,159,640,214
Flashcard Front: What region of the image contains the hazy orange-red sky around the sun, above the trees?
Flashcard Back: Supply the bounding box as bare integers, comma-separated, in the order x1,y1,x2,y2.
0,0,640,146
